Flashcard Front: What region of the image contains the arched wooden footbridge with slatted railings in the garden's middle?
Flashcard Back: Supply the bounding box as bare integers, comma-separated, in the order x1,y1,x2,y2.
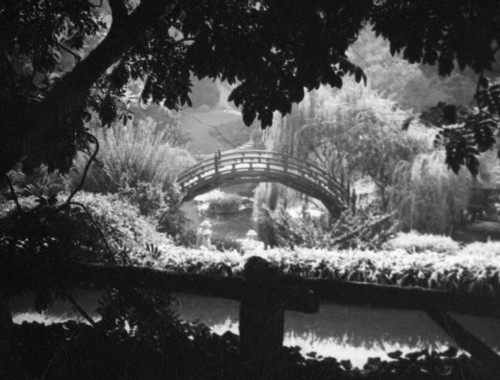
177,150,354,215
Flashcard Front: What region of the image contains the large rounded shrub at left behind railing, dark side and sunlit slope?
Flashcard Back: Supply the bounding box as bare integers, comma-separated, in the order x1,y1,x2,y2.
0,193,173,263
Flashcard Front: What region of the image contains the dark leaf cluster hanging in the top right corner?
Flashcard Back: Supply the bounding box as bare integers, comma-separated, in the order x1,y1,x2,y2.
370,0,500,75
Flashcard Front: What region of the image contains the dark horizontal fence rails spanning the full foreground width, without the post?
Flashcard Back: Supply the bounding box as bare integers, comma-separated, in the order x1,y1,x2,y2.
0,264,500,318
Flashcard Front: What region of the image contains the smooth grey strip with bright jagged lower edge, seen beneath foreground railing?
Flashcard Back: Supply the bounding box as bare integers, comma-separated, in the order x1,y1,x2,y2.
10,291,500,367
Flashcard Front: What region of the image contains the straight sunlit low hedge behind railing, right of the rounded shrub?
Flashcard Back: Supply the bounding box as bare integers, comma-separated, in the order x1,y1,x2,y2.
155,243,500,296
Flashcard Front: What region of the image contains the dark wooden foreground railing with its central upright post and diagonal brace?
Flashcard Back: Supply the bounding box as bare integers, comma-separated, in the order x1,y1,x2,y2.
6,257,500,379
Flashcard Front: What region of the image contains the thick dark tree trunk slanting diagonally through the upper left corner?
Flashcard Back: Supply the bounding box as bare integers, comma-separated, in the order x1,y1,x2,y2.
0,1,168,177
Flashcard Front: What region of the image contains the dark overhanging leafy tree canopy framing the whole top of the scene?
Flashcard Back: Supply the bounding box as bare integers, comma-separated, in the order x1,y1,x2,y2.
0,0,500,174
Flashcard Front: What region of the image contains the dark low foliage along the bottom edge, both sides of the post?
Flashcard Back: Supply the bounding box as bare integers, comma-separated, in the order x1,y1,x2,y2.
4,321,492,380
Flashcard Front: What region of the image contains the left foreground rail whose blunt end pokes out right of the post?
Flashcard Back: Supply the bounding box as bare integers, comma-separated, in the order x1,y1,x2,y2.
0,264,319,313
